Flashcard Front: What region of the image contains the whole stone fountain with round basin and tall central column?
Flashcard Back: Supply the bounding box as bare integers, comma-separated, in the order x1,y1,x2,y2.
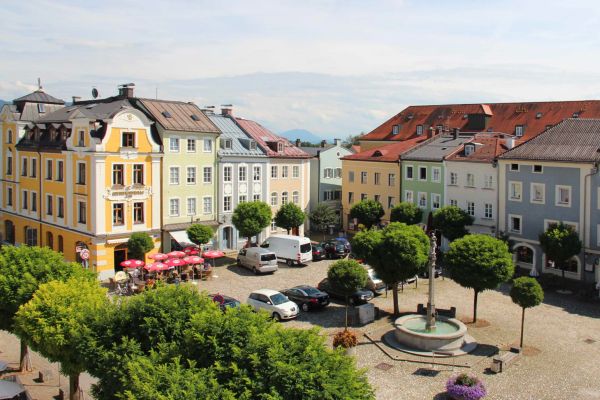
387,232,477,357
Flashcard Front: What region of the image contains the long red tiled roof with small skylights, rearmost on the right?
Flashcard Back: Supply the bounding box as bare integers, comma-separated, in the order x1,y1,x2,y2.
360,100,600,141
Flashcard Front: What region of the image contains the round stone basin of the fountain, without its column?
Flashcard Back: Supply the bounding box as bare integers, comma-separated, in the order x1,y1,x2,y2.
394,314,467,352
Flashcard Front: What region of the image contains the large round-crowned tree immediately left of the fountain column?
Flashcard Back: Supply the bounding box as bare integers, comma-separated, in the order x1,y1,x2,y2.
367,222,429,315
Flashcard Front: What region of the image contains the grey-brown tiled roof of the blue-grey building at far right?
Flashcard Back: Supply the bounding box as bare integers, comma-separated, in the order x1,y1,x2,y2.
499,118,600,162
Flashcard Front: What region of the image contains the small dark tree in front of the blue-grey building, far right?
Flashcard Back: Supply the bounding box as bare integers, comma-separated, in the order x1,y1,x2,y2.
539,222,581,289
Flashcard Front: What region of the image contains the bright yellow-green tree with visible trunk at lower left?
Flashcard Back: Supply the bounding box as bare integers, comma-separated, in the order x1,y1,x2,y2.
15,278,109,400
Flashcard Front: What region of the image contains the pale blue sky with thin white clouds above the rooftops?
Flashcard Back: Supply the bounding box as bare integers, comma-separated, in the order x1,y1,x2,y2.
0,0,600,139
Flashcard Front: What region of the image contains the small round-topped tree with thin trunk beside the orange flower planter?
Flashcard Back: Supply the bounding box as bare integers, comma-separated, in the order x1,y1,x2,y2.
327,260,368,330
